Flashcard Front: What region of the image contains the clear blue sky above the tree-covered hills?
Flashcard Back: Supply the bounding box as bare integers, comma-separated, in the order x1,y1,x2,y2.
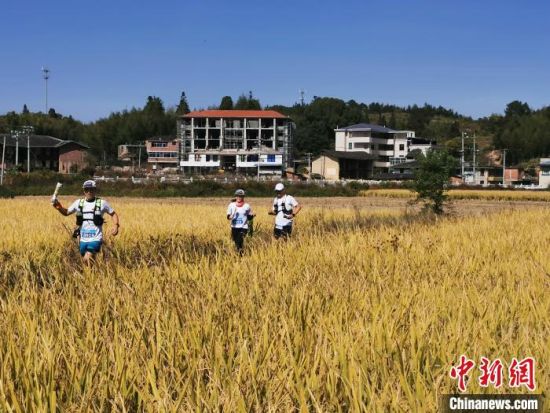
0,0,550,121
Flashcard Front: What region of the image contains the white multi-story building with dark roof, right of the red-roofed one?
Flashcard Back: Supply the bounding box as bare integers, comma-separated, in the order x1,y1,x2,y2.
335,123,435,173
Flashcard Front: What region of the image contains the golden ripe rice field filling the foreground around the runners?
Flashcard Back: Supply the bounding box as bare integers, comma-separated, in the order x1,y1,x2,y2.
0,196,550,412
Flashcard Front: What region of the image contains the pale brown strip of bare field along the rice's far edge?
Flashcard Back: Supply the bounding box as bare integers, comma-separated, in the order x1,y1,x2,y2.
28,197,550,215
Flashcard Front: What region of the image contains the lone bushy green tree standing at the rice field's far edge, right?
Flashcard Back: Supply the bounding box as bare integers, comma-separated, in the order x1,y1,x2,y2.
413,150,458,215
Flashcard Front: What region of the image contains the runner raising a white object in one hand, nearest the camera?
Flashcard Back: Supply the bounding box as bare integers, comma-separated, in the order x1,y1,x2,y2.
53,180,120,265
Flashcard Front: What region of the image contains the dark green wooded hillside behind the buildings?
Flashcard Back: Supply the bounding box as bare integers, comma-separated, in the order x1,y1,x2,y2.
0,92,550,164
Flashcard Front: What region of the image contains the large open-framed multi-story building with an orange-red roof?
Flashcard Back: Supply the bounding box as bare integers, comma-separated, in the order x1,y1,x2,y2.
178,110,294,174
